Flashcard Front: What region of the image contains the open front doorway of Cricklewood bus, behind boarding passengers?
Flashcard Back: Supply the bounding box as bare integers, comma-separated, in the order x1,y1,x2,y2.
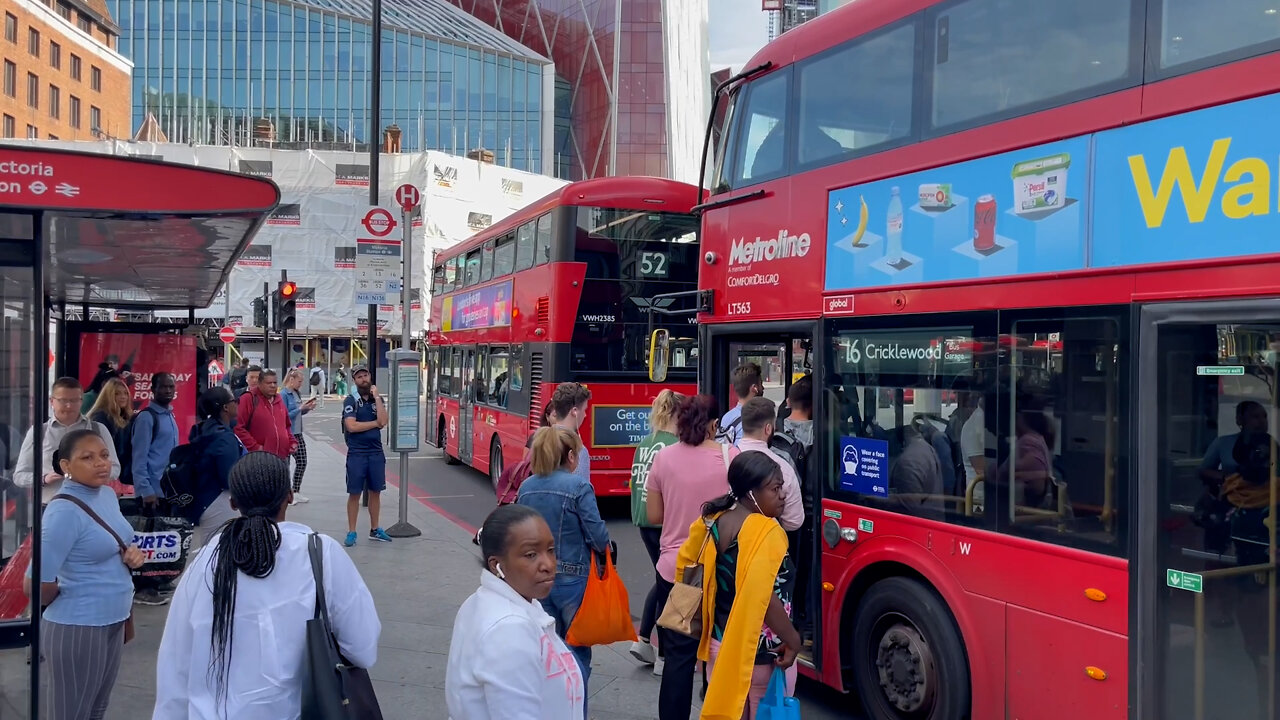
699,322,822,669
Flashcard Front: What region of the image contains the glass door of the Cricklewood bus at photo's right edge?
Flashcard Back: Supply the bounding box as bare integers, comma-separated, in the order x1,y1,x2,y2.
1133,300,1280,720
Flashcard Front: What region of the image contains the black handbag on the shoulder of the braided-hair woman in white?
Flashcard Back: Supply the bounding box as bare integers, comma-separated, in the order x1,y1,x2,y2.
302,533,383,720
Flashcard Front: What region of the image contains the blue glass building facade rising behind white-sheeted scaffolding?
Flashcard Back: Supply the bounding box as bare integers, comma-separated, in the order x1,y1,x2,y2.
108,0,554,173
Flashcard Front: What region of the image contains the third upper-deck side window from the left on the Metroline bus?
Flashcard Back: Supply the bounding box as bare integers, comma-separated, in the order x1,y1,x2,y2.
931,0,1140,132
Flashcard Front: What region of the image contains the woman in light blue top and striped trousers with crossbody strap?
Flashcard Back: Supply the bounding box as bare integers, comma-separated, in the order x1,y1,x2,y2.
26,430,146,720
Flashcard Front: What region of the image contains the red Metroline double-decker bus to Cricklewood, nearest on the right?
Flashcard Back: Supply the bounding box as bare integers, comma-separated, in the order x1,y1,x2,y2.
670,0,1280,720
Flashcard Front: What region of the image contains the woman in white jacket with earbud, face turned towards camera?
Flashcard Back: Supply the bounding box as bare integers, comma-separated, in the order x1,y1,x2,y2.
444,505,586,720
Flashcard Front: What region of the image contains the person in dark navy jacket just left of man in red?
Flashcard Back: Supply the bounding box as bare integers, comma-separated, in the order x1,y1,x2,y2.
183,386,246,548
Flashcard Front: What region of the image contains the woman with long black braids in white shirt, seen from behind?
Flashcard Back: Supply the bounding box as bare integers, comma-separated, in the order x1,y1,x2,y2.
152,452,381,720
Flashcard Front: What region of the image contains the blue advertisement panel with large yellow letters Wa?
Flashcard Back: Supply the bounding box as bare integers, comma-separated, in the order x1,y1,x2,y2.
1091,95,1280,266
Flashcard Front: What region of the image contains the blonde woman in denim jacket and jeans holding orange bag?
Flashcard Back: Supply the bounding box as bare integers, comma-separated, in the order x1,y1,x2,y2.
516,427,609,702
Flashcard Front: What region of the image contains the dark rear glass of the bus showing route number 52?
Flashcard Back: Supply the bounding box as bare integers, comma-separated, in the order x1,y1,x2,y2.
572,208,699,375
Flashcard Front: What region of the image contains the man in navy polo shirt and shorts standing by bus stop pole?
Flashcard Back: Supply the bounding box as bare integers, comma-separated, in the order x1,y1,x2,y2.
342,365,392,547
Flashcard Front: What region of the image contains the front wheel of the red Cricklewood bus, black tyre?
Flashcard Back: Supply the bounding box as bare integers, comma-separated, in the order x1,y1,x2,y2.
852,578,969,720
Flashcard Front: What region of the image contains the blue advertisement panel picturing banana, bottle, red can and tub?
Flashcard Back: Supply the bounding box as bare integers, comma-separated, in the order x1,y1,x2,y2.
826,138,1091,290
